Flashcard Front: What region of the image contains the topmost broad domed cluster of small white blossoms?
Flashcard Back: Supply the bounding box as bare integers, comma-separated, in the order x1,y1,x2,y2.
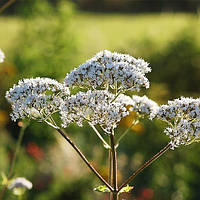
65,50,151,91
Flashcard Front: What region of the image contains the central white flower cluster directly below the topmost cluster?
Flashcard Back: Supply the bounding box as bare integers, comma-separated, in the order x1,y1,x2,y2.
60,90,129,134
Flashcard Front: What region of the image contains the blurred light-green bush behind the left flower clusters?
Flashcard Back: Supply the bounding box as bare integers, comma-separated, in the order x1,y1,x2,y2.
13,0,76,79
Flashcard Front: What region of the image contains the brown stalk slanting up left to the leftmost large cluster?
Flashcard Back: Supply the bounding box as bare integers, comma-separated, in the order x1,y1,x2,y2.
56,129,114,191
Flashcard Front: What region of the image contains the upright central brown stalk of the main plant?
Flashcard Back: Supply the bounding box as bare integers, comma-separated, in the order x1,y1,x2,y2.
110,132,118,200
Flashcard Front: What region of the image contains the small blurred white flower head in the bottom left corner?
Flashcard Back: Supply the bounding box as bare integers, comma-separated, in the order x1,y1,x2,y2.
8,177,33,190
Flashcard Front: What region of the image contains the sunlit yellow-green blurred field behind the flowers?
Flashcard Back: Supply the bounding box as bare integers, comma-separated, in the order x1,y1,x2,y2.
0,13,200,58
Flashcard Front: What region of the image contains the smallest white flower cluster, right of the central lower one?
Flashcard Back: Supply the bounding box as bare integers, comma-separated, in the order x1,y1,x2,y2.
131,95,159,119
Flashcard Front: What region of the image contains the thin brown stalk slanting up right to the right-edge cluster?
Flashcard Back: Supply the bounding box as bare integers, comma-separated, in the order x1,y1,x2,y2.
119,143,171,191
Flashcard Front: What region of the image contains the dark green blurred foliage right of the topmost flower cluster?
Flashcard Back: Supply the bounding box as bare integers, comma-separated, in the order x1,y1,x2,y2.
149,27,200,96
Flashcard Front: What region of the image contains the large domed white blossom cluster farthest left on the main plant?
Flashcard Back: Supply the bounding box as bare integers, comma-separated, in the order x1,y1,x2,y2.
6,77,70,121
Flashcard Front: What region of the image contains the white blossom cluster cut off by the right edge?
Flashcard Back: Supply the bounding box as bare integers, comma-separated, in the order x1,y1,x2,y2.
157,97,200,149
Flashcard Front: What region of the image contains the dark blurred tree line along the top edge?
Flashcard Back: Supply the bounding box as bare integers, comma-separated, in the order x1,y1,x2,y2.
0,0,200,14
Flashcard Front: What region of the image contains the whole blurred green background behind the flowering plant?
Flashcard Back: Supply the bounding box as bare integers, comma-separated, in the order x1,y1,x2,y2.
0,0,200,200
